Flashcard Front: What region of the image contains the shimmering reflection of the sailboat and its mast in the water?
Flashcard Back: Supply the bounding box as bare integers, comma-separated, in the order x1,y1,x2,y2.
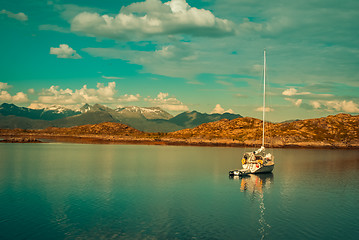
230,173,273,239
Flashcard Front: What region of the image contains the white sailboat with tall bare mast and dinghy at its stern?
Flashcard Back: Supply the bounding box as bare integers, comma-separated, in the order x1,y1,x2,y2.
229,49,274,176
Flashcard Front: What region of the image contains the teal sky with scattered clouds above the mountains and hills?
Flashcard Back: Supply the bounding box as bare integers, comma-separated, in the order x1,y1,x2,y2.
0,0,359,122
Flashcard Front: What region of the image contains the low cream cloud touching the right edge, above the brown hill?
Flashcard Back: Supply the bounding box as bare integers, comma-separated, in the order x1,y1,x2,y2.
310,100,359,113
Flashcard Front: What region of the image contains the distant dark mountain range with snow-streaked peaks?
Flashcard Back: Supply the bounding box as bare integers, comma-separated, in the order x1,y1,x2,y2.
0,103,242,132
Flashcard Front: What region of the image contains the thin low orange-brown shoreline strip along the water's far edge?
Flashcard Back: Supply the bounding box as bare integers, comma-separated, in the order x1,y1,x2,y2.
0,133,359,150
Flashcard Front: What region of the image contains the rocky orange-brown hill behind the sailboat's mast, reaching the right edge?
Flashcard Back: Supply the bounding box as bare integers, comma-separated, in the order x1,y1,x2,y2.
168,114,359,146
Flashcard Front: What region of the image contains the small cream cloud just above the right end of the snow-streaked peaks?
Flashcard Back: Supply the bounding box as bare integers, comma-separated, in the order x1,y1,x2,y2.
144,92,188,111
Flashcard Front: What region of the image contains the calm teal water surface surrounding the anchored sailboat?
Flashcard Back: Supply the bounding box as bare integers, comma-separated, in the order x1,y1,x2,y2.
0,143,359,239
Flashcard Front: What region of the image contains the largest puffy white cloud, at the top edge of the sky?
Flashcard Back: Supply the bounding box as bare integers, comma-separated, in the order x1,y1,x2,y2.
71,0,235,40
